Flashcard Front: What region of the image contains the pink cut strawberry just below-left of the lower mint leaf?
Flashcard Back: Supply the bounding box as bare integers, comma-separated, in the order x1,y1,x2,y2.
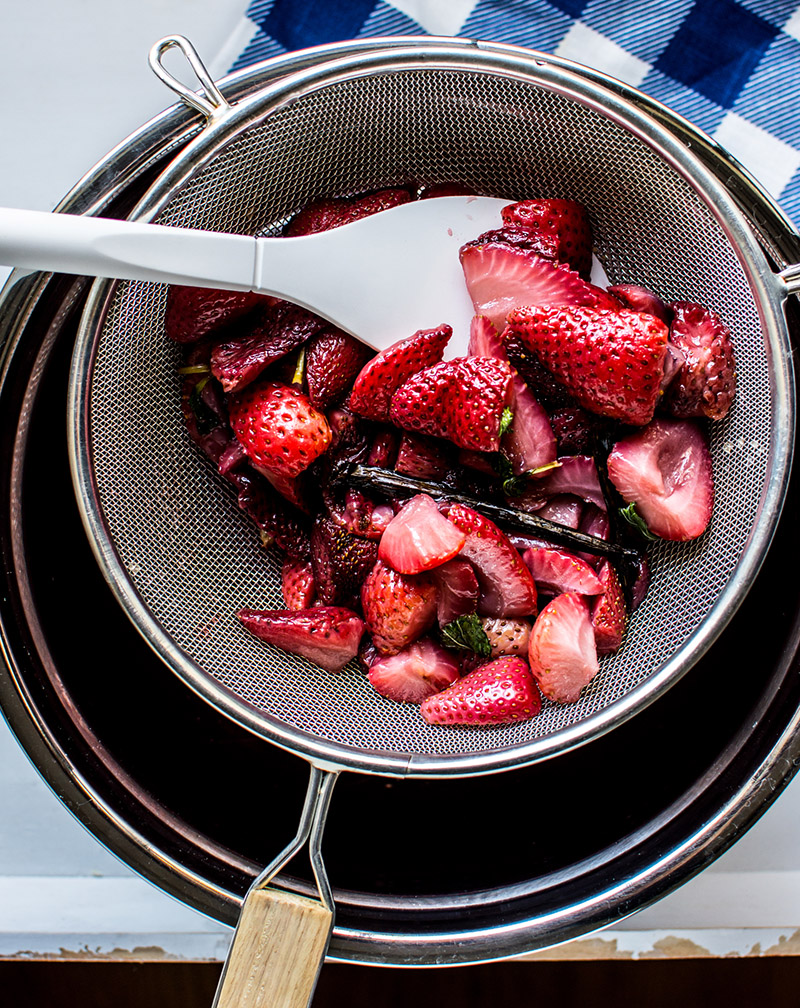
367,637,461,704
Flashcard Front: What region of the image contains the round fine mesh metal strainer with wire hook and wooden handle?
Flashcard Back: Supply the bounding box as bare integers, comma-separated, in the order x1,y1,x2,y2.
70,39,796,1004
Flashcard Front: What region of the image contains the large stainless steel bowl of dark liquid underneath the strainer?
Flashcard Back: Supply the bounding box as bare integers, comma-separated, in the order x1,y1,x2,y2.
0,33,800,966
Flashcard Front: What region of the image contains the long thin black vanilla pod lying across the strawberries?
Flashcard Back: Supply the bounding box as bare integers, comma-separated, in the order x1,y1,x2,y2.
332,463,640,565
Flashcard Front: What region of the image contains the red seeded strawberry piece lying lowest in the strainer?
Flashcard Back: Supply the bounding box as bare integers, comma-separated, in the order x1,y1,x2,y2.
419,656,542,725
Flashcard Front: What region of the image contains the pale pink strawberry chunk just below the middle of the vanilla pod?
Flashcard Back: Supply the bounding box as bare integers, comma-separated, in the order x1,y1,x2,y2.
378,494,466,574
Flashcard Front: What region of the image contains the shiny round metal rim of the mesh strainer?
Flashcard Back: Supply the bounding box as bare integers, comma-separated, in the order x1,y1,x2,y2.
69,40,795,776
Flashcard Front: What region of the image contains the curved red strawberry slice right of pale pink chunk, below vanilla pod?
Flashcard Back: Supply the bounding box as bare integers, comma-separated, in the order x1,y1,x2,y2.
447,504,536,618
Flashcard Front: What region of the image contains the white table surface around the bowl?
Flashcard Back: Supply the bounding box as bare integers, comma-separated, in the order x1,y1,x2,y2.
0,0,800,960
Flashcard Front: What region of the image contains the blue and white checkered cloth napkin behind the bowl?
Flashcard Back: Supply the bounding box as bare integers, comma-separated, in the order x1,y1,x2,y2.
219,0,800,225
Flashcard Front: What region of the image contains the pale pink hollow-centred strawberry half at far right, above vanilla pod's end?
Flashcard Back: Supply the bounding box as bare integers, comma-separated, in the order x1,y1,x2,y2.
608,418,713,540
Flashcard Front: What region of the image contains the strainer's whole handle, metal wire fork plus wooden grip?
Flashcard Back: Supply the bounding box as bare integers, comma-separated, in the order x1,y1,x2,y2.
213,766,338,1008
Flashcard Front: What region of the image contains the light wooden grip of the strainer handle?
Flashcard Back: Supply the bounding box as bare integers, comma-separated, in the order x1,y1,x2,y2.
215,889,334,1008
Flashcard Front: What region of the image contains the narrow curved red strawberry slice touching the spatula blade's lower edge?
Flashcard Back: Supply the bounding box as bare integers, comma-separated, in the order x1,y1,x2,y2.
349,326,452,422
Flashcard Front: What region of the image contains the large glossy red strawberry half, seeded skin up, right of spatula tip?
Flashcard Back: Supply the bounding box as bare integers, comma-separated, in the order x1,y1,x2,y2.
508,306,669,424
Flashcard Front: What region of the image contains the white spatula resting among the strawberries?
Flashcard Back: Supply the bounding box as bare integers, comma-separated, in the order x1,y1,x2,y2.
0,196,511,356
